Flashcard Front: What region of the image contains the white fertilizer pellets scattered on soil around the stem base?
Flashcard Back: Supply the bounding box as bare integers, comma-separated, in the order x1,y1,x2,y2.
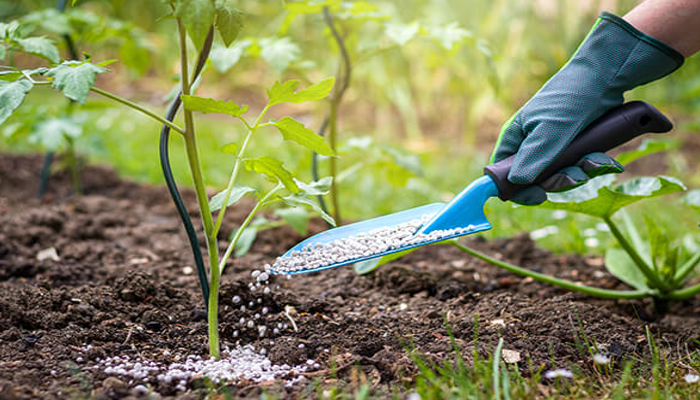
94,345,311,391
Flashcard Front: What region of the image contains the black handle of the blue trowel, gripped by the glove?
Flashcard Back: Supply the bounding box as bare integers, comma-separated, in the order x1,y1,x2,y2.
484,101,673,201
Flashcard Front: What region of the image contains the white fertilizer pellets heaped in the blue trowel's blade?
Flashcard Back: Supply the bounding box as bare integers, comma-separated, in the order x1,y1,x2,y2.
271,214,474,274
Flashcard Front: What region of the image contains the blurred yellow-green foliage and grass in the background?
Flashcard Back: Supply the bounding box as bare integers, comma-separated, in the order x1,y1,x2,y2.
0,0,700,252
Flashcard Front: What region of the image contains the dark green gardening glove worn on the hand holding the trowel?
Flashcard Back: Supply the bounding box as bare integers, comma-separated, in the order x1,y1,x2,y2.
491,12,683,205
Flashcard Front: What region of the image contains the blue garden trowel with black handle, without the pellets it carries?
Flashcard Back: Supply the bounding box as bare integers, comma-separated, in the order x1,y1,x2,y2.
271,101,673,274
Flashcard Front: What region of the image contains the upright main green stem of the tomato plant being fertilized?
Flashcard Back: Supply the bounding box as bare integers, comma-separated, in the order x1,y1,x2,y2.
177,18,221,359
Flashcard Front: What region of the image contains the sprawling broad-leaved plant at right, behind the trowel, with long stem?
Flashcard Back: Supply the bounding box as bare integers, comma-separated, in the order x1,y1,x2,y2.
355,140,700,313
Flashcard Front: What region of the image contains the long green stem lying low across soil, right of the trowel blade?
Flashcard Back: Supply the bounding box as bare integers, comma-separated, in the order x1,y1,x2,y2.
446,240,651,299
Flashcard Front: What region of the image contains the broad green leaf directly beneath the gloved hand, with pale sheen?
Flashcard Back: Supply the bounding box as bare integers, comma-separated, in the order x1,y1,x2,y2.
539,175,686,218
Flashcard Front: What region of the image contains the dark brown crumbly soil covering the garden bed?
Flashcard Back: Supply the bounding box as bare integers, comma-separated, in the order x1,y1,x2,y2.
0,154,700,399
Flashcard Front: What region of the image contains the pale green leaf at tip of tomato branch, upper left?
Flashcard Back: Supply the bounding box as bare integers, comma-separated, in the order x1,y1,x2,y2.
46,61,107,104
